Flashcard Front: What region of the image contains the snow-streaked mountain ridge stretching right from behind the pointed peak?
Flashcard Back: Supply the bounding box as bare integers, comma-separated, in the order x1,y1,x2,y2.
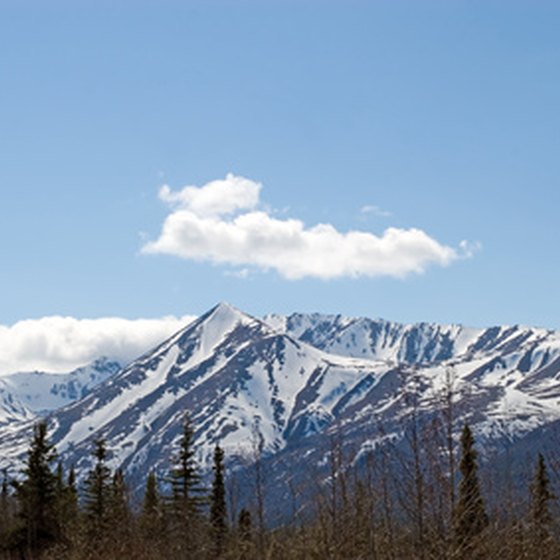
266,314,560,443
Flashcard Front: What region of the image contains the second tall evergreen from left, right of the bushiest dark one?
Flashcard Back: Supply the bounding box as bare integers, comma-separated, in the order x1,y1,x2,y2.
84,439,111,538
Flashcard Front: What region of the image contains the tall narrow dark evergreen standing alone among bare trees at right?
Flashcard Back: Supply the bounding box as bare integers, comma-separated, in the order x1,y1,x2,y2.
455,424,488,548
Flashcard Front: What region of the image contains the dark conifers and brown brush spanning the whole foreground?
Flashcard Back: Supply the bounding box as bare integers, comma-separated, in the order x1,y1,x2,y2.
0,417,560,560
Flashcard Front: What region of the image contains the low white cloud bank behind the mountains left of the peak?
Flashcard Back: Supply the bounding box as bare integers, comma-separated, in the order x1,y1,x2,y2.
0,316,194,375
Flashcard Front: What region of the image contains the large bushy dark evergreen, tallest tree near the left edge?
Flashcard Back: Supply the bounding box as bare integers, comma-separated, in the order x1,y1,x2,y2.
15,422,58,556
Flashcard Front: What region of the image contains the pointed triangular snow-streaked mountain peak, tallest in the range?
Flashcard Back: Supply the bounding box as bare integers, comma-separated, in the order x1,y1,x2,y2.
4,304,386,486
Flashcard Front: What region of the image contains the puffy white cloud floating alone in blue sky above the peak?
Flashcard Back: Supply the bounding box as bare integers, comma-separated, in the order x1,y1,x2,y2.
142,174,465,280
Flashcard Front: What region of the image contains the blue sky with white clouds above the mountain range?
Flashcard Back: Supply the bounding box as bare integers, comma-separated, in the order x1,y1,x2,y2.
0,0,560,373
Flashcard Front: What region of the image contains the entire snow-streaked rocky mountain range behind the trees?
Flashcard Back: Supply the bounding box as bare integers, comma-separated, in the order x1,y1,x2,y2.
0,304,560,516
